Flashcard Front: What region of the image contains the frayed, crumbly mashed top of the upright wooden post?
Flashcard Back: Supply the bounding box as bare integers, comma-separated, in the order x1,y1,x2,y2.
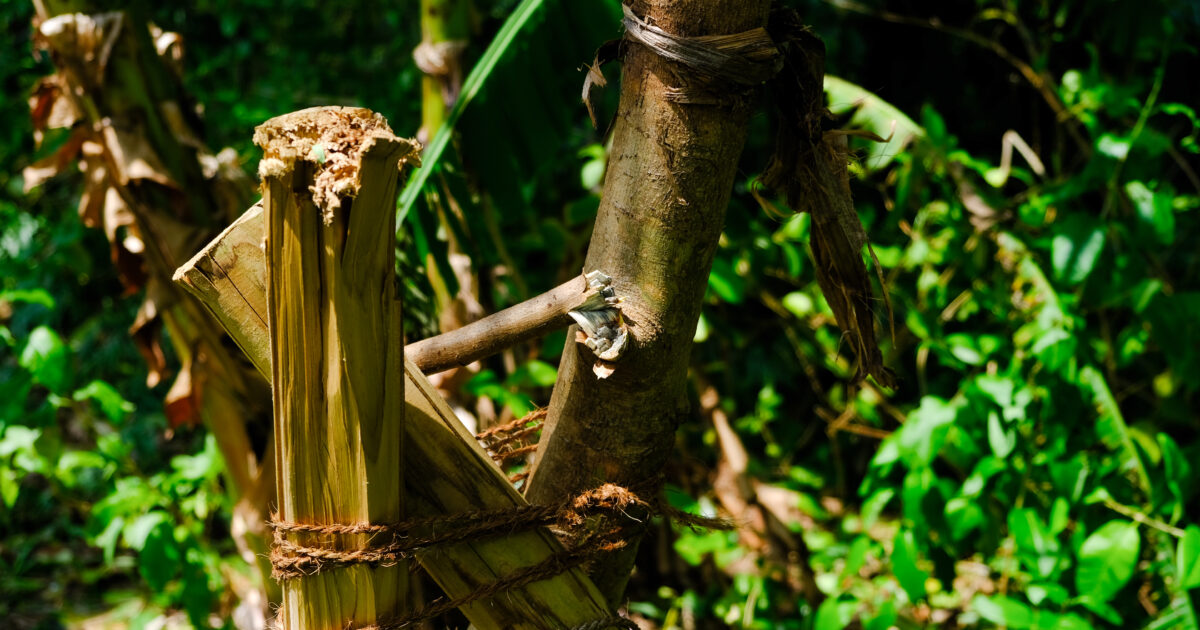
254,107,421,223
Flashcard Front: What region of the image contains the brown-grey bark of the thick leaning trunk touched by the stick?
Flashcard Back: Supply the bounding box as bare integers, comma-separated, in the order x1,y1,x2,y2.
528,0,768,604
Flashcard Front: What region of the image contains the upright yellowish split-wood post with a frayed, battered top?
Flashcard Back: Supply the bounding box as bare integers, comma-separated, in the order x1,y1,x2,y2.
256,108,416,630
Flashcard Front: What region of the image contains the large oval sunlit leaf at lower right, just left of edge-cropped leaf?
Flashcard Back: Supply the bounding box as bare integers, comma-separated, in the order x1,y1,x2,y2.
1075,520,1141,601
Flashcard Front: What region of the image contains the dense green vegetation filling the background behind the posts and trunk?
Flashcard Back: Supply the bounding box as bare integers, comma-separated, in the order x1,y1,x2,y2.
0,0,1200,630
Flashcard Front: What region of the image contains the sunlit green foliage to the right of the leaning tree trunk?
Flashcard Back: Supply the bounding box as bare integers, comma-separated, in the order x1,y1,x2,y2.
667,2,1200,628
